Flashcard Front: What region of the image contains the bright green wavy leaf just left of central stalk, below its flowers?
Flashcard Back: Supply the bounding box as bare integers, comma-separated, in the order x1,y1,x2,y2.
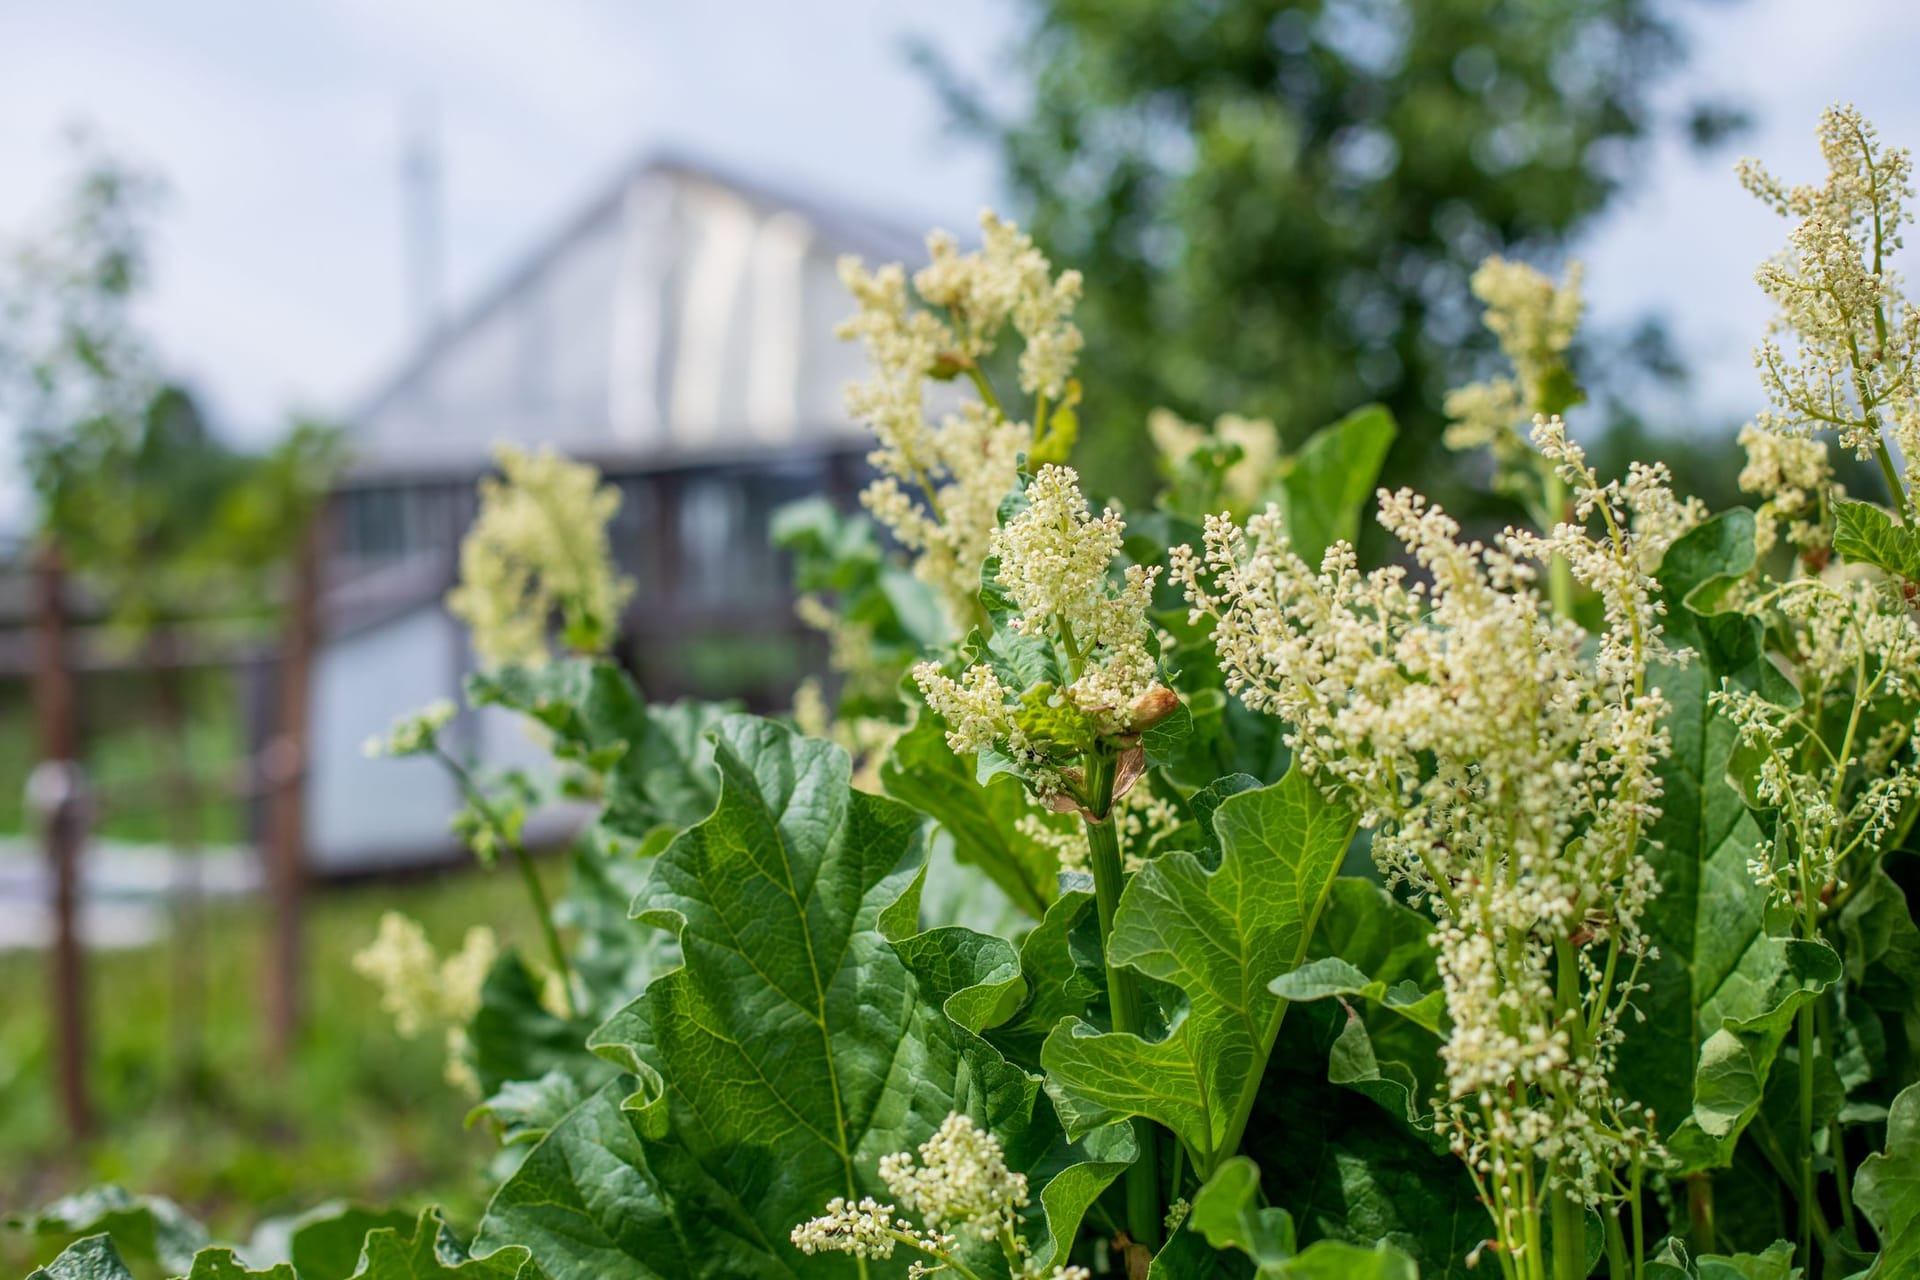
879,712,1060,919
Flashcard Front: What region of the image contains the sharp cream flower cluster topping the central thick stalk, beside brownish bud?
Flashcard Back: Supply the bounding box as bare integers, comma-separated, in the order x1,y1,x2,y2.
914,466,1171,796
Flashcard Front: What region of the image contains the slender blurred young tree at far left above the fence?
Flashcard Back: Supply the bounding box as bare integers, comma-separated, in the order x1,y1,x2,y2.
0,136,338,635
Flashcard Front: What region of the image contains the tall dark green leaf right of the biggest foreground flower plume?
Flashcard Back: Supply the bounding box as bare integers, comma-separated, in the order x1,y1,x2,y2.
1617,510,1837,1169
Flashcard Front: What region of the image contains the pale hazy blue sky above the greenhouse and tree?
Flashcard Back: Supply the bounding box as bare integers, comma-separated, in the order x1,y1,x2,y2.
0,0,1920,518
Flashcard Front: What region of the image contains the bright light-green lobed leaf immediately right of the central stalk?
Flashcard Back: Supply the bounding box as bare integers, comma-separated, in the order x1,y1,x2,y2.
1041,770,1354,1174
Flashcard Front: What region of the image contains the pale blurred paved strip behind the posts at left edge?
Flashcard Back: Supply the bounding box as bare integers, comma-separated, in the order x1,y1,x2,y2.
0,837,261,950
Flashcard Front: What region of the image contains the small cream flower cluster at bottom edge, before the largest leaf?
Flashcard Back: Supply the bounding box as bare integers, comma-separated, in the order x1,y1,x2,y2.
791,1113,1091,1280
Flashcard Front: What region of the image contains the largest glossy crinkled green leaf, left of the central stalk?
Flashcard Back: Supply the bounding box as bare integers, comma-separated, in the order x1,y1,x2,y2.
480,716,1075,1280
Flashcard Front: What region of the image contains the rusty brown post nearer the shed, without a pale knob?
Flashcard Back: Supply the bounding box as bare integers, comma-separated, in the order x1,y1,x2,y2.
265,509,324,1067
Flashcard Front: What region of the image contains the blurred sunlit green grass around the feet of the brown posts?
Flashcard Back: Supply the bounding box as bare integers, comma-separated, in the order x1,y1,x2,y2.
0,864,561,1276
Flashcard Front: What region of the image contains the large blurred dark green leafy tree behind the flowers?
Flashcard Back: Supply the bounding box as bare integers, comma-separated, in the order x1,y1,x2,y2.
918,0,1741,499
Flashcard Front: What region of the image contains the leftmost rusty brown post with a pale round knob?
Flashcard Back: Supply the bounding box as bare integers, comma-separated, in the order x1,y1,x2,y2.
31,539,92,1138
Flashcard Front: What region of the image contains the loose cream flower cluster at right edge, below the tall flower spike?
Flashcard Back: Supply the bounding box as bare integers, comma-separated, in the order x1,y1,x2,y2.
1713,578,1920,909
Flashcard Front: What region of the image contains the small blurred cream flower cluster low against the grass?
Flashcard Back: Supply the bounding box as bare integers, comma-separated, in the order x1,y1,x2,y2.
353,912,499,1092
